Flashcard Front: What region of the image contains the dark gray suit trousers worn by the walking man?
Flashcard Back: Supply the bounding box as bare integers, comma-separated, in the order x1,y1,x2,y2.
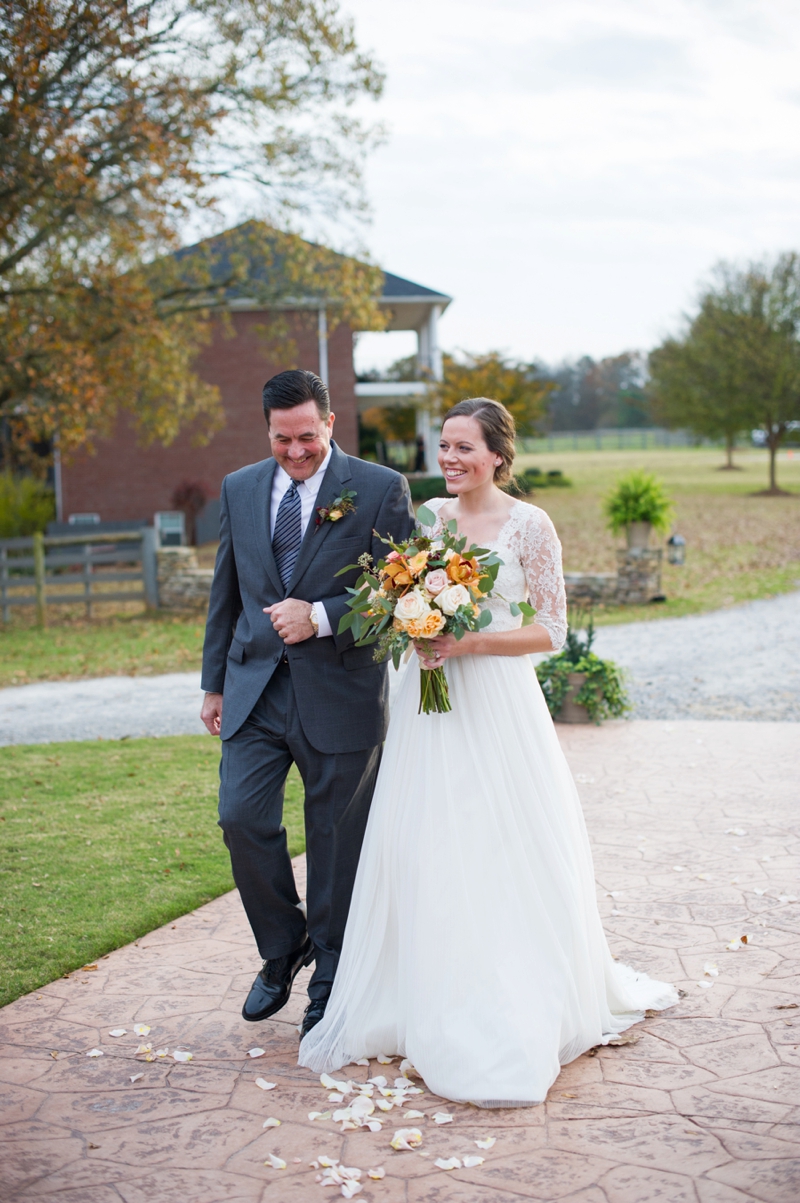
219,663,381,998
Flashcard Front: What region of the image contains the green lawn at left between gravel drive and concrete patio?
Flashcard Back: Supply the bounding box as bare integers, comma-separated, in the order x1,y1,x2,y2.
0,735,304,1006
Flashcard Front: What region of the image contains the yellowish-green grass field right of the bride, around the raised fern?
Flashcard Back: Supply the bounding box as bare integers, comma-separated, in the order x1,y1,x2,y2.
517,449,800,623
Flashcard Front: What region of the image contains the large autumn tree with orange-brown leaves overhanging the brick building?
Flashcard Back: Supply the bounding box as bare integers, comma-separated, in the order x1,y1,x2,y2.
0,0,381,466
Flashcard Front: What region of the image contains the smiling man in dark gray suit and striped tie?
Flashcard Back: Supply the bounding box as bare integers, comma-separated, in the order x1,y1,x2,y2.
202,372,414,1035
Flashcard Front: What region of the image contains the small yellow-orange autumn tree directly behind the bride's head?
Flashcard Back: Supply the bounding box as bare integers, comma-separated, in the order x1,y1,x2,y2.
433,351,553,435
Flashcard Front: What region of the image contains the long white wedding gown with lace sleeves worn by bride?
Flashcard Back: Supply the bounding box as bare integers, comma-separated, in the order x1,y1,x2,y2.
300,498,677,1107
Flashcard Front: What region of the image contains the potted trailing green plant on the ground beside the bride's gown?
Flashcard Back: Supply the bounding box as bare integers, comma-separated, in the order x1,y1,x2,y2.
537,611,630,725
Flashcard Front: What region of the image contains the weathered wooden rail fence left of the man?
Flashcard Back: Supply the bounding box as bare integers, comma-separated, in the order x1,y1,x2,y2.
0,527,158,627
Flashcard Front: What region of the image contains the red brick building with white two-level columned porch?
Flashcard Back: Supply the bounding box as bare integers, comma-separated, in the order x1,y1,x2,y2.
57,229,451,541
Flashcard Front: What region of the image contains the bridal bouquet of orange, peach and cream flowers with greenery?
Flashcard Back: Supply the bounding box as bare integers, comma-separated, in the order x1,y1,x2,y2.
337,506,503,715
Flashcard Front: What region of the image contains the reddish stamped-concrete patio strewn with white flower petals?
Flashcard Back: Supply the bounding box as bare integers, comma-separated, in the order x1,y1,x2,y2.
0,721,800,1203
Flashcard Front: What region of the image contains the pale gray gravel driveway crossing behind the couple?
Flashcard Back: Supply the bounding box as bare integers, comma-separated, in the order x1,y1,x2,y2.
0,593,800,745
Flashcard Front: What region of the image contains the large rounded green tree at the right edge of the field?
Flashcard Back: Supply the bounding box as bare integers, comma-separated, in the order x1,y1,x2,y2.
650,253,800,494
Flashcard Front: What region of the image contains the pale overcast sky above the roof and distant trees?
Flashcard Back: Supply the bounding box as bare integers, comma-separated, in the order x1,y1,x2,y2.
343,0,800,367
